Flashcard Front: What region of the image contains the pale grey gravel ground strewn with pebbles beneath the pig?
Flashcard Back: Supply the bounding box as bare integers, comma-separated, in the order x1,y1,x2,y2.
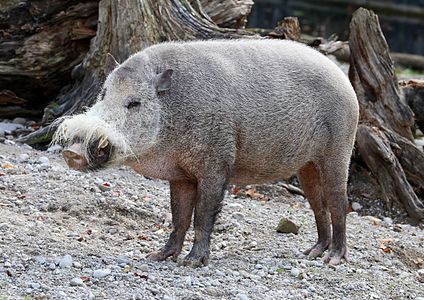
0,141,424,300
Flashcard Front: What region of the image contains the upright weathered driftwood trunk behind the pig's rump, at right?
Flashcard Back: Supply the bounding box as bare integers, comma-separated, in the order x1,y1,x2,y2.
349,8,424,219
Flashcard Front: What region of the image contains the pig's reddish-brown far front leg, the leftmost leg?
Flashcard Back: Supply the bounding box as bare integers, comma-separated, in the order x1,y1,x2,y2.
147,180,197,261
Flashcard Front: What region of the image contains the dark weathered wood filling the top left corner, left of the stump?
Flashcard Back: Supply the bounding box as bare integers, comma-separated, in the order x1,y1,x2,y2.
0,0,98,118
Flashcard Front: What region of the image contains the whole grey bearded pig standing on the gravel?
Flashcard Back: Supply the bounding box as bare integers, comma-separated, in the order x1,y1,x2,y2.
56,40,358,266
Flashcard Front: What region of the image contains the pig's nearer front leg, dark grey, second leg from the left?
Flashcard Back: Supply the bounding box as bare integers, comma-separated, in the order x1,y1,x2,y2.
179,178,226,267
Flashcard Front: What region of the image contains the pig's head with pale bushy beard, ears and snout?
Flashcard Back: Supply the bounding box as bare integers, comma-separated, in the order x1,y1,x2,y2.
53,54,172,171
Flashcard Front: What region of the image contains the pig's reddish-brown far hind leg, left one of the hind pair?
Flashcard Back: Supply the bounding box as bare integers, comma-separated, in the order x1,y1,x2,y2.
298,162,331,258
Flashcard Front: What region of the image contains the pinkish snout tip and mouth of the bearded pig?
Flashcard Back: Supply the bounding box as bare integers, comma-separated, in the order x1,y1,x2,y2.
63,138,113,171
